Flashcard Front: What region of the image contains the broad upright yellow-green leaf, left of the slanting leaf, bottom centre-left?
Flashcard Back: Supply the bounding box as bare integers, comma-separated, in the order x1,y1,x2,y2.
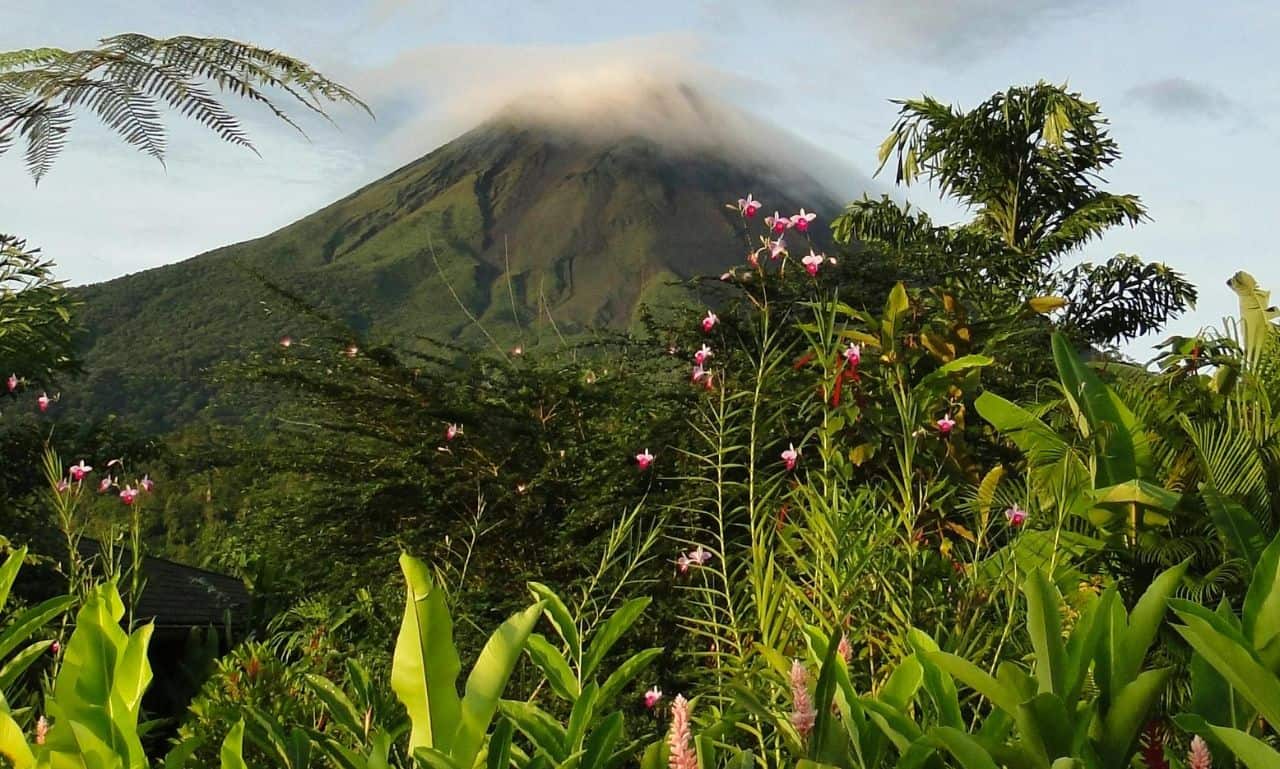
392,554,462,752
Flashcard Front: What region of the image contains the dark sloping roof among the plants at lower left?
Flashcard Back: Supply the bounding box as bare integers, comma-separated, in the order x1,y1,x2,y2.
79,539,250,630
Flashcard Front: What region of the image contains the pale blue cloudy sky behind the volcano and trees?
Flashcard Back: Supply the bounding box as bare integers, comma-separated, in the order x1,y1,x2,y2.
0,0,1280,358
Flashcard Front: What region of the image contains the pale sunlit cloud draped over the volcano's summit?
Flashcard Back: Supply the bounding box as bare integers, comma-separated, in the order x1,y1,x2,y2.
355,36,870,196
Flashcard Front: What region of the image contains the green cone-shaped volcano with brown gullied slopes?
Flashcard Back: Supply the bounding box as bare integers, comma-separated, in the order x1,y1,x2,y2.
65,92,837,430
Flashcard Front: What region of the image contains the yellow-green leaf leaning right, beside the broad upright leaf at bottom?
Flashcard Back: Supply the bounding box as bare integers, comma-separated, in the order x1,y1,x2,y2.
448,601,545,766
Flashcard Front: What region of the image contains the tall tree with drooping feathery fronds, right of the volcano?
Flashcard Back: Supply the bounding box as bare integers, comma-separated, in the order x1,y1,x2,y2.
833,82,1196,344
